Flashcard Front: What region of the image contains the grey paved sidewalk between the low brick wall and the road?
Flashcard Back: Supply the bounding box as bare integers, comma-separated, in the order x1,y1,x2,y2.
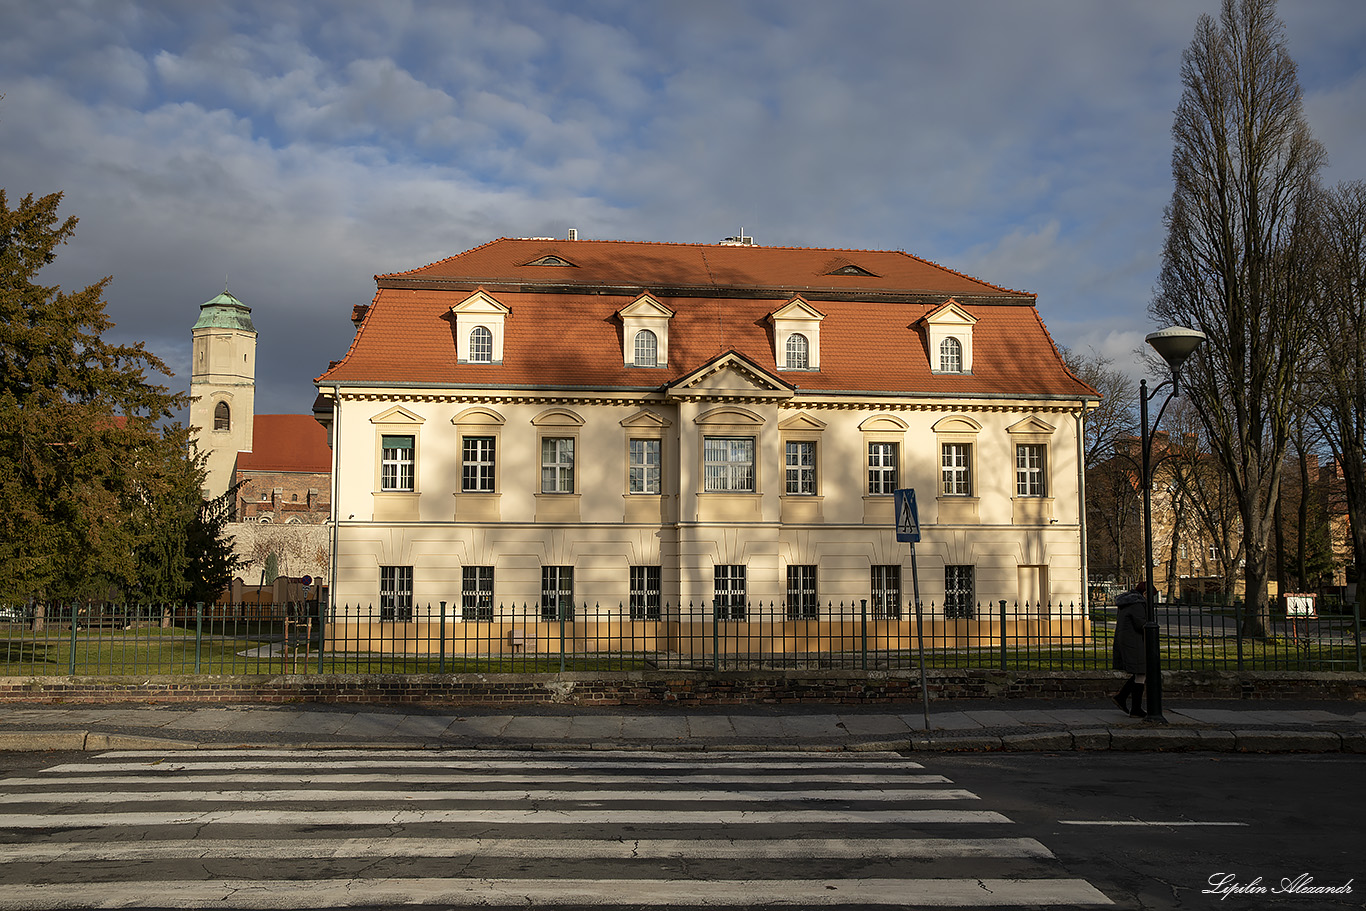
0,699,1366,753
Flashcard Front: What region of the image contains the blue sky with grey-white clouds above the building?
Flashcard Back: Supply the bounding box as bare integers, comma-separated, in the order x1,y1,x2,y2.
0,0,1366,412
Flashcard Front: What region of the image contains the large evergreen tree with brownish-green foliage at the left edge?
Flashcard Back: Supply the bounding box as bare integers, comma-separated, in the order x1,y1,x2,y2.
0,190,211,600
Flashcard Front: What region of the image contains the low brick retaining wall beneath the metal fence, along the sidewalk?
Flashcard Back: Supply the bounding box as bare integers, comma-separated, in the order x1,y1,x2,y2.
0,671,1366,706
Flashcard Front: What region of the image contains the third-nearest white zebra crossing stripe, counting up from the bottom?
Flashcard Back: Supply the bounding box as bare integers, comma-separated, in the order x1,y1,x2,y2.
0,807,1009,829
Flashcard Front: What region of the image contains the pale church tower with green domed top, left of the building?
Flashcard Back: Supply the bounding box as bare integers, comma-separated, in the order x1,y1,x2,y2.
190,290,255,497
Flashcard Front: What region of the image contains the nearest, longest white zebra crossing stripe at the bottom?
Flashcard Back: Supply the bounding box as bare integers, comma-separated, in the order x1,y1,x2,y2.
0,878,1113,911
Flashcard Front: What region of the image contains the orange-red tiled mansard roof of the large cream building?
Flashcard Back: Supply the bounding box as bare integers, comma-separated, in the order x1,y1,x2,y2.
317,240,1096,397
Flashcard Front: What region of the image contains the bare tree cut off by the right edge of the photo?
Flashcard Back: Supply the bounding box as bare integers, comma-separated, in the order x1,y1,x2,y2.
1314,182,1366,613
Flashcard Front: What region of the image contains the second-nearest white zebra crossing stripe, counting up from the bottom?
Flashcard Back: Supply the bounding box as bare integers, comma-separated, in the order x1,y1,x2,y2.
4,837,1053,863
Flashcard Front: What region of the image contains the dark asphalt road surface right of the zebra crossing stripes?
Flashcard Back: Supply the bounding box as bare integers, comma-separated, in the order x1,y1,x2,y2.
917,753,1366,911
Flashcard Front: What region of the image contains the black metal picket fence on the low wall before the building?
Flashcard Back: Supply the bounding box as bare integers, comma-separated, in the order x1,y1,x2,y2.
0,600,1362,677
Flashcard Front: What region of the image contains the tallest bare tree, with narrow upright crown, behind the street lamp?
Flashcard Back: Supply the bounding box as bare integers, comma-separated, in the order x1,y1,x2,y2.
1150,0,1324,635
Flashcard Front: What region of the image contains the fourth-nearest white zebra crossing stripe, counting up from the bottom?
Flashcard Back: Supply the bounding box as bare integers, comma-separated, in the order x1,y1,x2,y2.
0,781,978,806
